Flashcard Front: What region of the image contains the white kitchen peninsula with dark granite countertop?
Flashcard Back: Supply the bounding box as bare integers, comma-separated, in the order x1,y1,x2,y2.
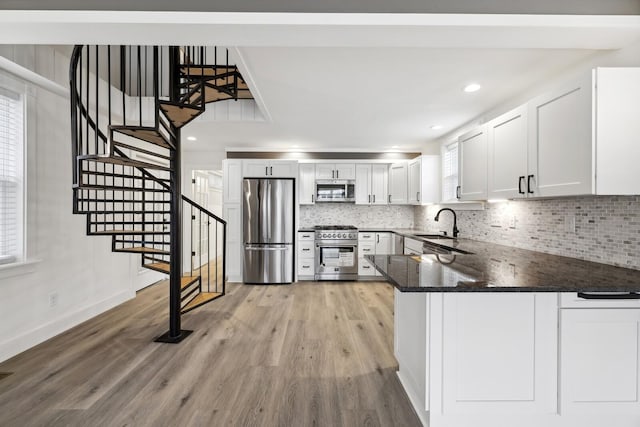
366,239,640,427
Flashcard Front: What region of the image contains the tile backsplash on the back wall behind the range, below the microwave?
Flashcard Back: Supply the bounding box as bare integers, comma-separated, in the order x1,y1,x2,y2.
300,203,414,228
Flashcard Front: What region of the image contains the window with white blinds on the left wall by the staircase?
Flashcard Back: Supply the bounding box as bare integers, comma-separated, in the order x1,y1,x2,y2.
0,87,24,265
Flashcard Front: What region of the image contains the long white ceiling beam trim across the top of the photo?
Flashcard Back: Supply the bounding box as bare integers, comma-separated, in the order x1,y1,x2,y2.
0,10,640,49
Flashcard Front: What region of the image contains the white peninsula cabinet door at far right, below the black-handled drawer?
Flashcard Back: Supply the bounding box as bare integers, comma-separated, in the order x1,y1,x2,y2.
560,308,640,418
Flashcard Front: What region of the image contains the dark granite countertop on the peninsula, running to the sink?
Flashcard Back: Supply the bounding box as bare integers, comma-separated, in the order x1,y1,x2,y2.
366,237,640,292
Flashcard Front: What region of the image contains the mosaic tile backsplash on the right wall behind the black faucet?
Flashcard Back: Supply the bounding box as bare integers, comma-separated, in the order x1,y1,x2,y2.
414,196,640,270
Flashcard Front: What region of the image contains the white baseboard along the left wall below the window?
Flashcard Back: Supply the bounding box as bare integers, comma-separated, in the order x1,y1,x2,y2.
0,291,136,362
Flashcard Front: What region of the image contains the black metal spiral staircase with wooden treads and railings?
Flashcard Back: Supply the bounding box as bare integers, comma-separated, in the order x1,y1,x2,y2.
70,46,242,342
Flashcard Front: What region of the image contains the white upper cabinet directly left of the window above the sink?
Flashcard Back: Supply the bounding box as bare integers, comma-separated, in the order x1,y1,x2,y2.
408,156,440,205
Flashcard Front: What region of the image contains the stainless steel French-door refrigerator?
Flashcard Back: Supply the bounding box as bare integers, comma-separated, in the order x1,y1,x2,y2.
242,178,295,284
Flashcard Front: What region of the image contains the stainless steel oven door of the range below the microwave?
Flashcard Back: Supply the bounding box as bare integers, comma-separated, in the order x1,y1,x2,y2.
315,241,358,280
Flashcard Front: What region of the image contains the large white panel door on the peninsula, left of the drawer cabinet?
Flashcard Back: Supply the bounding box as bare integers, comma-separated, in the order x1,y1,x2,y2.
442,292,558,416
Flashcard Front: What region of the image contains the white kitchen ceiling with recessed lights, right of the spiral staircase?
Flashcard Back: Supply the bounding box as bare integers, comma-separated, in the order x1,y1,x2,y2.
183,47,594,151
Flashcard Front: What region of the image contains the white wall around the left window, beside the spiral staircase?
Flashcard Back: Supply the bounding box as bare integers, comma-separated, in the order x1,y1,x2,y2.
0,46,158,361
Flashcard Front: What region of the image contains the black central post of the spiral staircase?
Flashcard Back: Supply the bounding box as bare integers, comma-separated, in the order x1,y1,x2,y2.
155,46,193,344
